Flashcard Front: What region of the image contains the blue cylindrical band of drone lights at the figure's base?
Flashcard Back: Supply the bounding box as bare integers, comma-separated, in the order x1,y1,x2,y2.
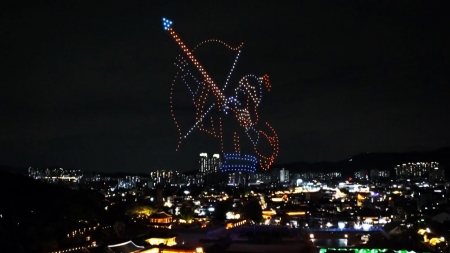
221,153,258,173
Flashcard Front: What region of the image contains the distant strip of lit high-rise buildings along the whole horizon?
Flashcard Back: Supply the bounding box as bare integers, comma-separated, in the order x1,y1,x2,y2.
28,153,445,192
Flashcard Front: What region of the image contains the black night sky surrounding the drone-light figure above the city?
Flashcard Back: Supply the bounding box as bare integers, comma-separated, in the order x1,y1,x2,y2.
0,0,450,172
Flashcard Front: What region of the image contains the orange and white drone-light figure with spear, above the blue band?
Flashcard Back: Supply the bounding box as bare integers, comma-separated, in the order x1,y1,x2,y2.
163,18,278,170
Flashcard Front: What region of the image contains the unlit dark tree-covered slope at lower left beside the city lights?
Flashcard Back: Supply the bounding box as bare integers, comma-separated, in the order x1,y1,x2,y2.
0,171,109,252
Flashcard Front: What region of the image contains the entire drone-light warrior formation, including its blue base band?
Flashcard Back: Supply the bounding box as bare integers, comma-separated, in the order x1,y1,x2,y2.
163,18,278,173
